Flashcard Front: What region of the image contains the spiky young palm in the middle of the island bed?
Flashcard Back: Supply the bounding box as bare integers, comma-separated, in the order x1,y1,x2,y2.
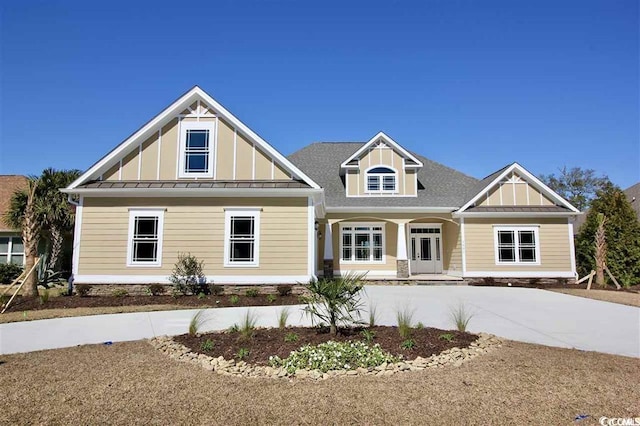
303,273,364,336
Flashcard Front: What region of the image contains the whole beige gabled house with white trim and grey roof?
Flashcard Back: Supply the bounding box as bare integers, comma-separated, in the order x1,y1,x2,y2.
64,87,580,284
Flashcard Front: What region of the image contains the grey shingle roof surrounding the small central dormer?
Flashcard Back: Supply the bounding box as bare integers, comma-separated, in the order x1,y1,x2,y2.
288,142,478,207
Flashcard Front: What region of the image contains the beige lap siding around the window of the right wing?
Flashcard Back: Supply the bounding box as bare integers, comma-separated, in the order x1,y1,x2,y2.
465,218,571,272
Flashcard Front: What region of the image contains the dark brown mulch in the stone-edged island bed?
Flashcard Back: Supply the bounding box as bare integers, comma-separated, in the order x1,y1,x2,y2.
174,326,478,365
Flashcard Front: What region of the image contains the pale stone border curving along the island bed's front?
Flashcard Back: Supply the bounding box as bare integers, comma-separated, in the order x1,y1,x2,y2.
149,333,503,380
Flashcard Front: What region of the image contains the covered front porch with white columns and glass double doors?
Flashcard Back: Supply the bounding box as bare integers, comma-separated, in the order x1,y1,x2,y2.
317,213,462,281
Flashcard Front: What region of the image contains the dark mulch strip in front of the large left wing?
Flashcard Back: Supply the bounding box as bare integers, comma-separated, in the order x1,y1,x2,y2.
7,294,301,312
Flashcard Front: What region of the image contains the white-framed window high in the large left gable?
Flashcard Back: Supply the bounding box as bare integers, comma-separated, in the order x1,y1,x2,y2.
178,121,215,178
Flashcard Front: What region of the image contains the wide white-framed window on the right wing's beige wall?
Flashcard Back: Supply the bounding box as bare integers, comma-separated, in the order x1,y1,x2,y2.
494,226,540,265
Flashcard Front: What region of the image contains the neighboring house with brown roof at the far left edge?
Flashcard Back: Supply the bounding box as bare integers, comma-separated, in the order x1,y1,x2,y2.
0,175,27,265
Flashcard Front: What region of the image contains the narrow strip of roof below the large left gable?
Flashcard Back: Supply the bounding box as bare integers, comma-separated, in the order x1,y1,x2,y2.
78,179,309,189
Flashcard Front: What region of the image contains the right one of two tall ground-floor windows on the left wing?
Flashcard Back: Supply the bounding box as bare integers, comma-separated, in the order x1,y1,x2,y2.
224,208,260,267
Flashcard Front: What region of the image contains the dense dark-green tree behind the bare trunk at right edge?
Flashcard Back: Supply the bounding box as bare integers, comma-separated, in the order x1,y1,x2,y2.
576,184,640,287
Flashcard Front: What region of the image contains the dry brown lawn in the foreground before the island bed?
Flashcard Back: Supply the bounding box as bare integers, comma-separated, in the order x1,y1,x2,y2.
0,341,640,425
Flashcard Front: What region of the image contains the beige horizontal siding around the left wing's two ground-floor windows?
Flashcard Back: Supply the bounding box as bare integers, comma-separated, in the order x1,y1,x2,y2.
78,198,308,282
